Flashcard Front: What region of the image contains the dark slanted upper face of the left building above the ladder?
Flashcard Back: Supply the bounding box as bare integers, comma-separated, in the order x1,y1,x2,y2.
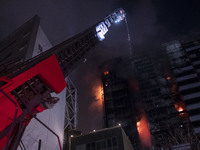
0,16,39,69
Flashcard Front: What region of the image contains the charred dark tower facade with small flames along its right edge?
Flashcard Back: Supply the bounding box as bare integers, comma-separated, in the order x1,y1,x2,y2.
133,52,195,149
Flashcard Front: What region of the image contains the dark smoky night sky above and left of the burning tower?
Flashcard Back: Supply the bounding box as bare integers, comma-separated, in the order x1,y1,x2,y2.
0,0,200,131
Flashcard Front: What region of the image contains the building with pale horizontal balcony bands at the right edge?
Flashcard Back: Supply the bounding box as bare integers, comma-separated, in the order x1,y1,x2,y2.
164,40,200,134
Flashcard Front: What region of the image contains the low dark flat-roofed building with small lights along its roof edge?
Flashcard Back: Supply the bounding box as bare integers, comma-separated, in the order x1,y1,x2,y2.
71,126,133,150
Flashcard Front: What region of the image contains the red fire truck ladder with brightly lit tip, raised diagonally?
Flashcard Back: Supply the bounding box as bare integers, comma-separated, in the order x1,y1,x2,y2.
0,8,125,150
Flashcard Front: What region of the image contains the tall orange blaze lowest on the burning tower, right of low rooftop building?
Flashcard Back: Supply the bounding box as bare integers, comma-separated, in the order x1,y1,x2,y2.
137,114,152,148
